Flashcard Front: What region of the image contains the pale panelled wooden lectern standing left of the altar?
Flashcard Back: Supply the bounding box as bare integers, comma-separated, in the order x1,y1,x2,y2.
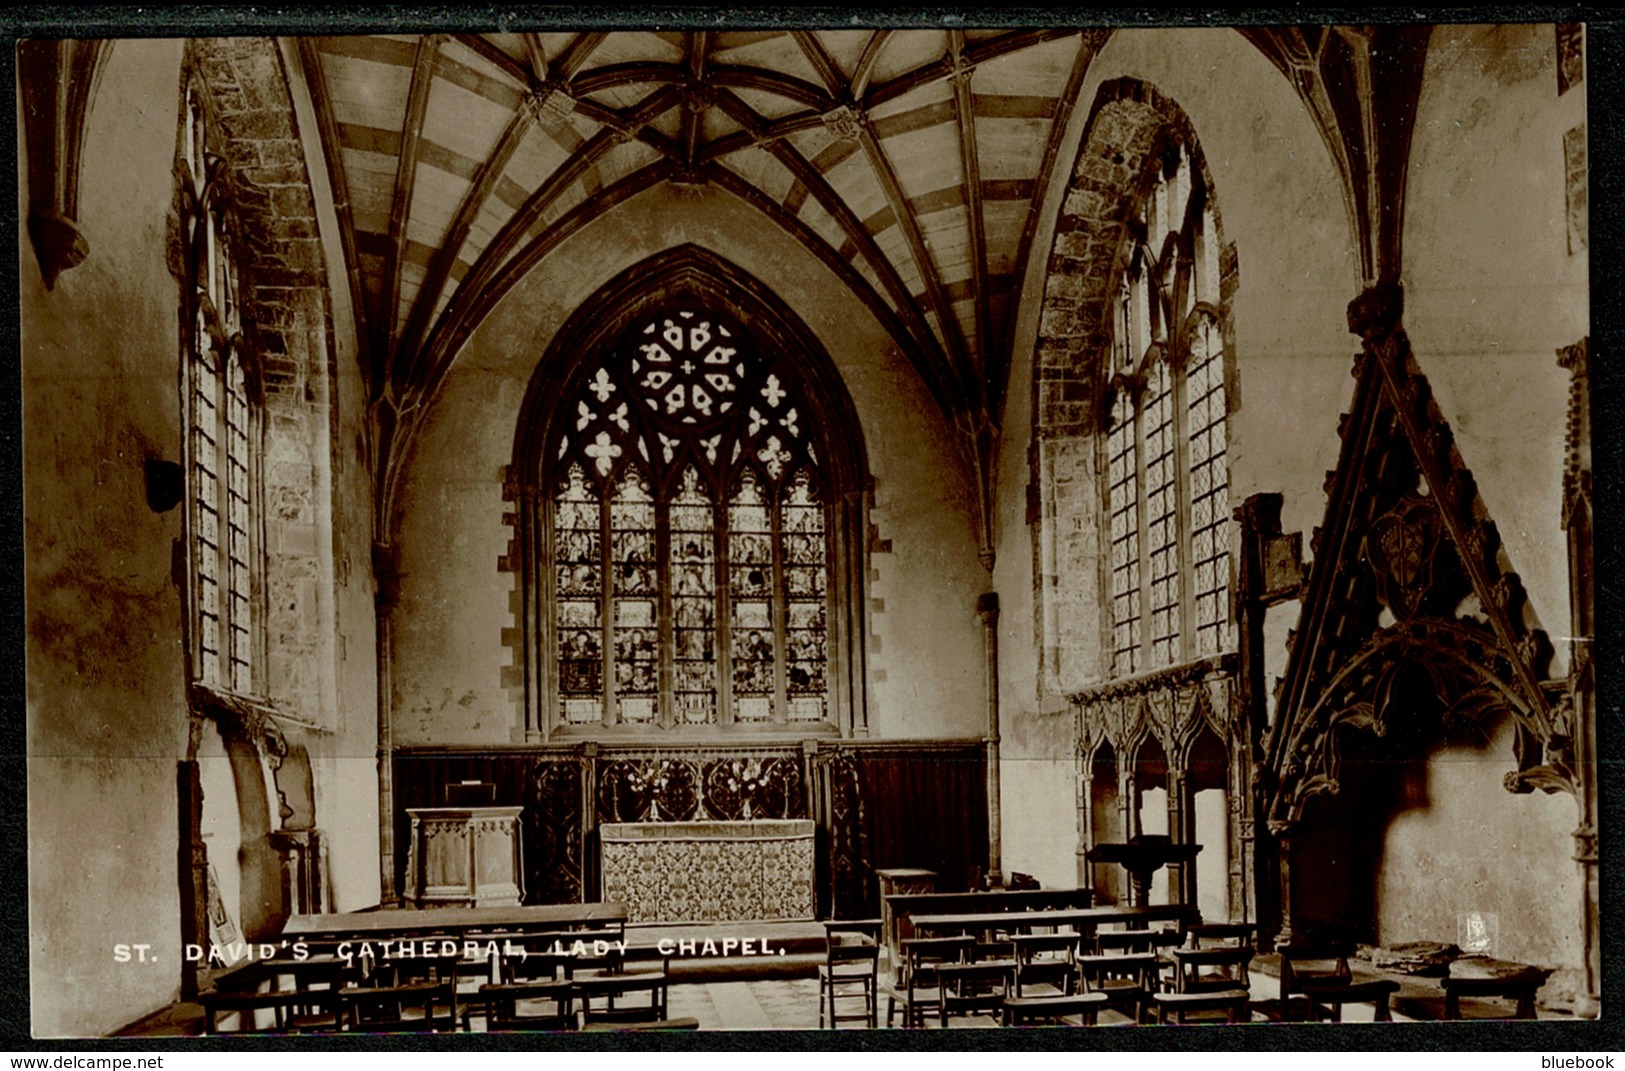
401,808,525,907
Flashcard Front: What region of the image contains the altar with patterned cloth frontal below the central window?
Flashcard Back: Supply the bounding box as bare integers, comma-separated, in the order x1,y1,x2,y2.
598,819,814,921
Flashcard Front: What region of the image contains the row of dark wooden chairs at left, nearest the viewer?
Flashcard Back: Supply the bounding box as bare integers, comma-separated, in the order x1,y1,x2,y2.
200,930,699,1034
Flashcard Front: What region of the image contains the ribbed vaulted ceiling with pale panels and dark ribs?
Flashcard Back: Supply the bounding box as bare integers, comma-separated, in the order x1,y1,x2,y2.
299,29,1105,432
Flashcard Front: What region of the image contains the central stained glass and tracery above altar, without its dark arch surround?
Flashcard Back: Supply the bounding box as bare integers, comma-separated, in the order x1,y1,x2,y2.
544,309,830,730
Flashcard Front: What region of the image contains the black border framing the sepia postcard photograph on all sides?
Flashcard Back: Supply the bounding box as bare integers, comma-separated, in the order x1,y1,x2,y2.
0,5,1625,1066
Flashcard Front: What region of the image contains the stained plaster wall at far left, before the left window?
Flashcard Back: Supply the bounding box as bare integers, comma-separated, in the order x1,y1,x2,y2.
18,35,187,1035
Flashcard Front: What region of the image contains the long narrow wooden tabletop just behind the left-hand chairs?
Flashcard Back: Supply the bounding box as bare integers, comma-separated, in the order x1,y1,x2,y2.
283,904,626,939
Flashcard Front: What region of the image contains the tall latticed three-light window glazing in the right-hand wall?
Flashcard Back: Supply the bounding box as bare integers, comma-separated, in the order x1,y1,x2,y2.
1105,145,1232,676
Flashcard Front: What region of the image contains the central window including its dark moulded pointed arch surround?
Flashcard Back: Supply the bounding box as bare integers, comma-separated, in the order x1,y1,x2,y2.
507,245,869,739
